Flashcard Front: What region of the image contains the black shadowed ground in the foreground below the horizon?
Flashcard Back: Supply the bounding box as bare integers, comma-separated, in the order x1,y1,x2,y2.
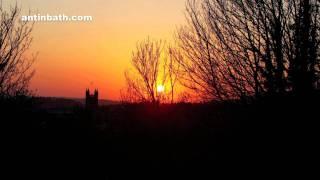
0,96,320,179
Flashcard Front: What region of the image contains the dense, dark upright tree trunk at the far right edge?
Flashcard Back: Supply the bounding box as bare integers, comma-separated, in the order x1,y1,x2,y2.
288,0,320,94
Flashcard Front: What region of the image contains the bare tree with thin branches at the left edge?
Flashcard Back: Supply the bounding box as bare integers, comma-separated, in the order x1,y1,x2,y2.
0,2,34,96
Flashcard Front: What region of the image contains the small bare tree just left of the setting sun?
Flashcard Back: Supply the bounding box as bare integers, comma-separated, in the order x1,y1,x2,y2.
122,38,164,104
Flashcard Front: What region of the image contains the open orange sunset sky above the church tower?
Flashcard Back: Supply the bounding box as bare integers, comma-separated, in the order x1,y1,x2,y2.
3,0,185,100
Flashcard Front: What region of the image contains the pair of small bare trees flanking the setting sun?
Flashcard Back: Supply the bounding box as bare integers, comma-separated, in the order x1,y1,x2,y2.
121,38,184,104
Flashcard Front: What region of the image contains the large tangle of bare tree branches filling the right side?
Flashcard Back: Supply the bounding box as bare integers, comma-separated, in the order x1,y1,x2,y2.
175,0,319,100
